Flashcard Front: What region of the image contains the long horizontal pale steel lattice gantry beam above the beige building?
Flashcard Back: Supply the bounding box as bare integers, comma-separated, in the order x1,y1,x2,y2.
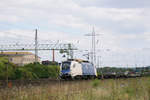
0,43,77,51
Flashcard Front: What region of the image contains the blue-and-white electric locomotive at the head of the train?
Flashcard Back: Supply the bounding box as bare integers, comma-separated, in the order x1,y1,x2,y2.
60,59,97,79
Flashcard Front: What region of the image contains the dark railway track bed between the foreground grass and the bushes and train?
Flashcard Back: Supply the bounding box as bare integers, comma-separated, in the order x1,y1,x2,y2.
0,75,141,88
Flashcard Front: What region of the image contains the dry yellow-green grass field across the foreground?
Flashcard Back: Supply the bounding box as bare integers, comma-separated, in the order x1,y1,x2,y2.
0,77,150,100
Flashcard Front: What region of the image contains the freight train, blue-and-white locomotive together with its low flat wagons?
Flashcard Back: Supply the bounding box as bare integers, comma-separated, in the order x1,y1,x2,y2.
60,59,142,79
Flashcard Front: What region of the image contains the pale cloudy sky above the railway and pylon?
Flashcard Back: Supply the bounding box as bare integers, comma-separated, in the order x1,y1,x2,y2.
0,0,150,67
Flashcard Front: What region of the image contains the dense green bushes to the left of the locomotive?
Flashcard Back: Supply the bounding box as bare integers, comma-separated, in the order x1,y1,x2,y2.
0,57,59,80
